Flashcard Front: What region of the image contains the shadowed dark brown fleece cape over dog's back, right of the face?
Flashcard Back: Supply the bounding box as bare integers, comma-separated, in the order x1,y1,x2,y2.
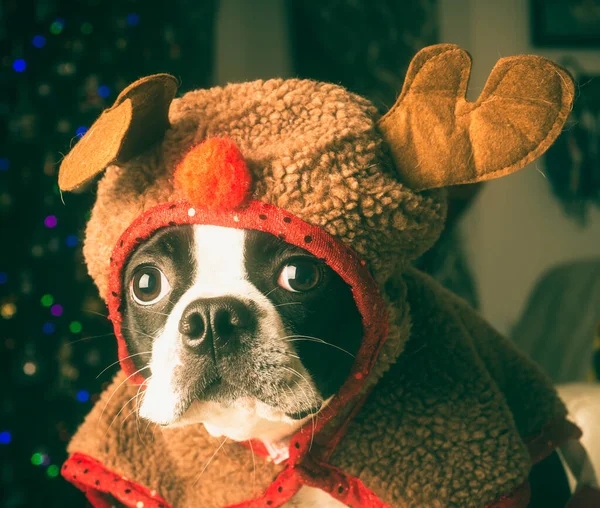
332,269,574,507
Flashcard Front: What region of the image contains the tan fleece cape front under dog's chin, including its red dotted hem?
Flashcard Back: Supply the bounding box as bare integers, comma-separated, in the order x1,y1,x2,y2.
62,372,282,508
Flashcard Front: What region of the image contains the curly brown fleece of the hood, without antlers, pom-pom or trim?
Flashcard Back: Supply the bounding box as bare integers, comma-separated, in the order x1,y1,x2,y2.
81,80,445,297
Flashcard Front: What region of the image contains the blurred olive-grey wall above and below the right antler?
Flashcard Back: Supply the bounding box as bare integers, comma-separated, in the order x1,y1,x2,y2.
440,0,600,333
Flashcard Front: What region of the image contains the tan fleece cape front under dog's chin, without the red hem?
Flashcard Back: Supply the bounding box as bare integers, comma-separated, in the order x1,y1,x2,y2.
68,372,283,508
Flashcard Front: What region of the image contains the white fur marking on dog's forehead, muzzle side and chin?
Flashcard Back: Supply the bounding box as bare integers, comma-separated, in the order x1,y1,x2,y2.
140,225,315,441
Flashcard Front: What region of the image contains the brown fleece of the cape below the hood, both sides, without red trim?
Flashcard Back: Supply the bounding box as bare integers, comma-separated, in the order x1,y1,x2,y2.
69,270,566,508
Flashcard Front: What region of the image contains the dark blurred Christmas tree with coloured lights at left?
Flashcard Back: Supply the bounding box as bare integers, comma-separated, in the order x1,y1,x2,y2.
0,0,215,508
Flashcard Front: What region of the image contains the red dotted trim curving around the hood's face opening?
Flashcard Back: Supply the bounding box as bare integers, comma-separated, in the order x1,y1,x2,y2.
108,197,388,464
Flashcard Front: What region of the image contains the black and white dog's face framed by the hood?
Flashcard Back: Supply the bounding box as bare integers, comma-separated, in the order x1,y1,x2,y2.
123,225,363,440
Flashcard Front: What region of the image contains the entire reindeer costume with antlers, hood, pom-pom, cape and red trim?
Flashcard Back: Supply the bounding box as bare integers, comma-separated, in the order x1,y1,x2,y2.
59,45,592,508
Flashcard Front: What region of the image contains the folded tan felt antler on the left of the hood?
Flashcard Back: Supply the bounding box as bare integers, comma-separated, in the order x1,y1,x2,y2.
58,74,177,191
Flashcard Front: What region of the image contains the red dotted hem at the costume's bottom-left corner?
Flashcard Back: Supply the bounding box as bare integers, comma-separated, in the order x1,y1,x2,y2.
61,452,172,508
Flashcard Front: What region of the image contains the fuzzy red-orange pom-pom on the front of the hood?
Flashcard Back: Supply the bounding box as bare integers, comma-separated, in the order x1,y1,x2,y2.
175,138,252,210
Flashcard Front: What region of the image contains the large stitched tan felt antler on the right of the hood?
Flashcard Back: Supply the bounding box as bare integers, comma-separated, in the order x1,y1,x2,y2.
378,44,574,190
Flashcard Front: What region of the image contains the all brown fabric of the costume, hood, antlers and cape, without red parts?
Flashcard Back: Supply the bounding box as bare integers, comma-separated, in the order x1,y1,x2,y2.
61,45,573,508
